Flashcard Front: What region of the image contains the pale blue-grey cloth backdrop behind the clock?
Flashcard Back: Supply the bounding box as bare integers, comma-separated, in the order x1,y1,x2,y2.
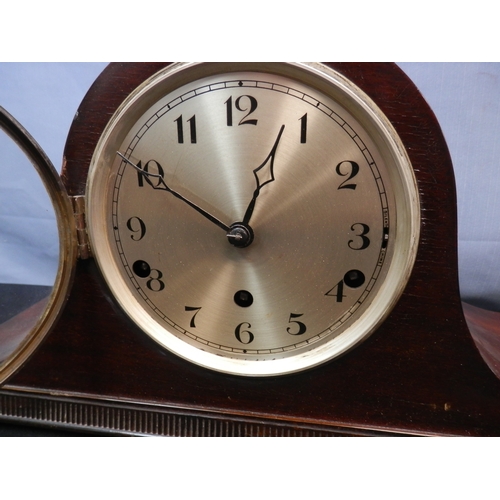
0,63,500,311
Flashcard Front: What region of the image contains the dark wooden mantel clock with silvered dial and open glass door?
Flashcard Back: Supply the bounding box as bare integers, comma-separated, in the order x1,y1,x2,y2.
0,63,500,435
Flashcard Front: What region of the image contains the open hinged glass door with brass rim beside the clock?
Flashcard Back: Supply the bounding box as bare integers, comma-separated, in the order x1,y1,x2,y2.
0,107,77,383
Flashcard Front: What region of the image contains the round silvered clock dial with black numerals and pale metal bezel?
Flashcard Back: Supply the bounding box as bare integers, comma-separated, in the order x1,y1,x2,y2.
87,64,419,375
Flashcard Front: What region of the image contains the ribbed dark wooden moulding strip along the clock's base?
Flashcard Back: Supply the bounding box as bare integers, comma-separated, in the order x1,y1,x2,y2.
0,388,397,437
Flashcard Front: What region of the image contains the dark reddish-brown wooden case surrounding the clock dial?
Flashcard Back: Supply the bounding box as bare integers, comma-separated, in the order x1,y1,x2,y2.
0,63,500,436
